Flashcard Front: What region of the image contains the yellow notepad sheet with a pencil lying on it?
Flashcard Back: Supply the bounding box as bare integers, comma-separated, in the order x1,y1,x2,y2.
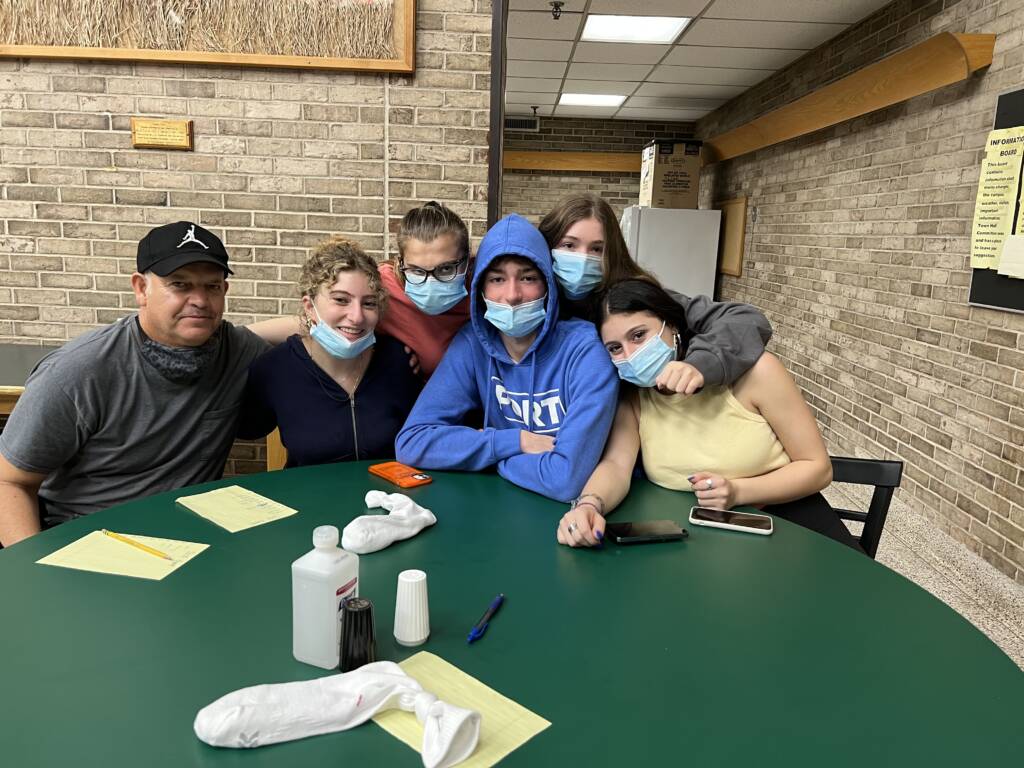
36,530,210,582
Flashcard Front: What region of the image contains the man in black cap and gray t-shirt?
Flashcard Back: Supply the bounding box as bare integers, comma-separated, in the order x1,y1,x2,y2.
0,221,276,546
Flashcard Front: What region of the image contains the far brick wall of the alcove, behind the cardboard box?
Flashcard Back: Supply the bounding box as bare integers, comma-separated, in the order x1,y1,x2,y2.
502,118,693,222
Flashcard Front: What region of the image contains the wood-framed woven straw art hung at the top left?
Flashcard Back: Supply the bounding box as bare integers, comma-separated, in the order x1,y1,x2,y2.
0,0,416,73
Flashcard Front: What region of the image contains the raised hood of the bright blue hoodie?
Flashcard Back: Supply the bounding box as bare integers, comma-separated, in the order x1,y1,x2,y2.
470,213,558,362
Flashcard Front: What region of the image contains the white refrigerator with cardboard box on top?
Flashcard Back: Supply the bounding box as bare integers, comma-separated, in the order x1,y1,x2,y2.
622,206,722,298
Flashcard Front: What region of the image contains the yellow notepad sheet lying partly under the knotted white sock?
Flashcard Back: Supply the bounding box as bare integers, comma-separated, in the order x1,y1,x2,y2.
374,651,551,768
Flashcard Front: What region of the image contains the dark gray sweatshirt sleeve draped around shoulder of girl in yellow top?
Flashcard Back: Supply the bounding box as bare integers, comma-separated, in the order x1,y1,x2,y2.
669,291,771,386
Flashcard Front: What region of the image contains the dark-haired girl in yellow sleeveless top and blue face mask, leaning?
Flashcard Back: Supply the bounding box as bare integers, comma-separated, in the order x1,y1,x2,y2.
557,280,835,546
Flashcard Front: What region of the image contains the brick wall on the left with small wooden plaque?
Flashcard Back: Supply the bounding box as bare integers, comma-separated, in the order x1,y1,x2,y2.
0,0,490,471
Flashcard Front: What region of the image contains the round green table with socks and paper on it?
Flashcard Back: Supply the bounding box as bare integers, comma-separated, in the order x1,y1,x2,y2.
0,463,1024,768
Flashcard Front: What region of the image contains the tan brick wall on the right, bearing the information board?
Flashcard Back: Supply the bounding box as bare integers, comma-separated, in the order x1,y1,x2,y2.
697,0,1024,584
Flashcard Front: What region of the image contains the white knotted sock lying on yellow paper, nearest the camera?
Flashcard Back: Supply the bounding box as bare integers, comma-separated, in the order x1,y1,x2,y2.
193,662,480,768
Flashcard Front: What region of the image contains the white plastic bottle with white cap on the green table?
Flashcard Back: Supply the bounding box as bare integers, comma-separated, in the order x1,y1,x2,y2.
292,525,359,670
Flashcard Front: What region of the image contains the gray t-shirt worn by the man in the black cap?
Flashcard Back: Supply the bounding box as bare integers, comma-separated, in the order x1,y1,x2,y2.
0,314,269,523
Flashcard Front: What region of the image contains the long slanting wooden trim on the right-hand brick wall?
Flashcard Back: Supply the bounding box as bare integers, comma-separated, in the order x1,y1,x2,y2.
705,32,995,163
